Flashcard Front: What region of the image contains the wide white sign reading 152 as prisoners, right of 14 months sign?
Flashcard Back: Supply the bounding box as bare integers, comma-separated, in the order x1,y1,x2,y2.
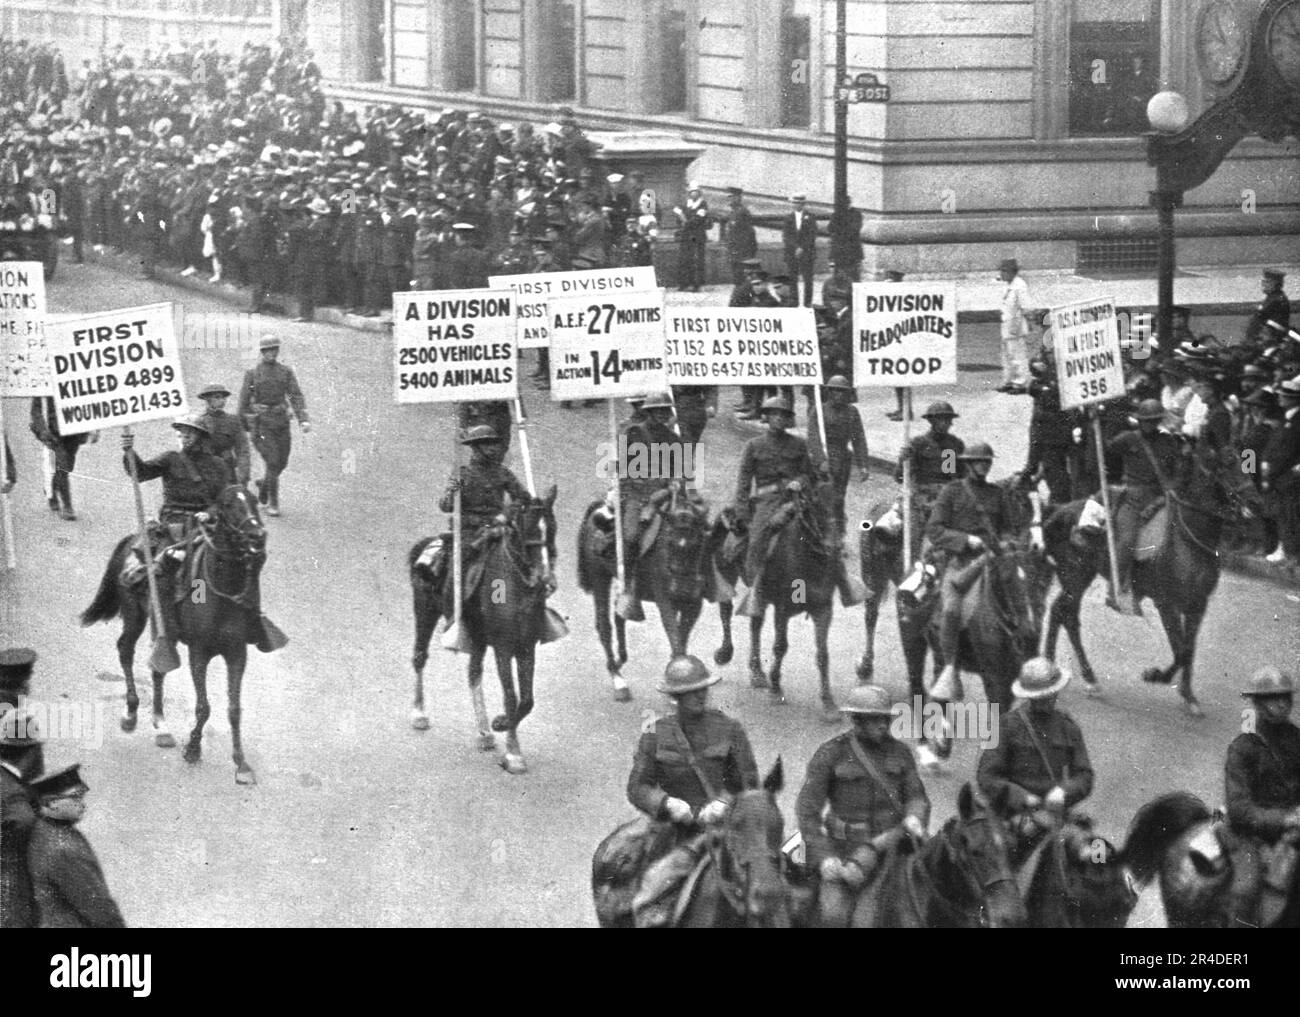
664,307,822,385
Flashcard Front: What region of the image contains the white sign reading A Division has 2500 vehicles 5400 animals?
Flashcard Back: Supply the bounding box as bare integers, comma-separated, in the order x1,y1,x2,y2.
393,290,519,403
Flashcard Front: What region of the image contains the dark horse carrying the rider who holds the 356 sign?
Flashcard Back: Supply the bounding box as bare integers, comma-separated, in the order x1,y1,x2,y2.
1044,453,1251,718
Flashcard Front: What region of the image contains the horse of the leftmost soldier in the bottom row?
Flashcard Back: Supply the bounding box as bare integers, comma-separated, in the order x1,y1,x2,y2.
592,758,792,929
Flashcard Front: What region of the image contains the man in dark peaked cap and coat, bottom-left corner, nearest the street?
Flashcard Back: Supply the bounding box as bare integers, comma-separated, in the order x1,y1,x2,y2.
27,763,126,929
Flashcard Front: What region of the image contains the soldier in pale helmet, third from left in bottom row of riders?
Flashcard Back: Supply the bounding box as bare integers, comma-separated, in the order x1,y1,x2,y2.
976,657,1092,860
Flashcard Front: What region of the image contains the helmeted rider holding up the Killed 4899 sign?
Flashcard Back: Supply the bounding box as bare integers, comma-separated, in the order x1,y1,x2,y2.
122,414,235,671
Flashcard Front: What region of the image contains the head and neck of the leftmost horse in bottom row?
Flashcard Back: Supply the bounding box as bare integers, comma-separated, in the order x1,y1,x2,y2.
718,758,790,927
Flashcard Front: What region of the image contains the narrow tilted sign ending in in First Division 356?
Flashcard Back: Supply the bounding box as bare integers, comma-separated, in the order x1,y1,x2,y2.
1052,299,1125,410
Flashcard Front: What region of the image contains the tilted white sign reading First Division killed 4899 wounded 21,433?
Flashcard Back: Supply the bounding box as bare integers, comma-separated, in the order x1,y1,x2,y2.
46,303,189,434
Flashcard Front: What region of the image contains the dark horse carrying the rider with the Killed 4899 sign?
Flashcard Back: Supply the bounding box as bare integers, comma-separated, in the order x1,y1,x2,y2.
81,484,271,784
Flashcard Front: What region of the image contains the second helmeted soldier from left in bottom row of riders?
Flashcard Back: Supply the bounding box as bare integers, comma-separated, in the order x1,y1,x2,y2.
794,685,930,929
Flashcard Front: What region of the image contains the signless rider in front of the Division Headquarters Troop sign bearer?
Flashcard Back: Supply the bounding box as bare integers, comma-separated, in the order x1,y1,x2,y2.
926,441,1017,700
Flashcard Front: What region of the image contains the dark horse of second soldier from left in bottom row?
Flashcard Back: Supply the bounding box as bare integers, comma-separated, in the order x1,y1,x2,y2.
852,784,1027,929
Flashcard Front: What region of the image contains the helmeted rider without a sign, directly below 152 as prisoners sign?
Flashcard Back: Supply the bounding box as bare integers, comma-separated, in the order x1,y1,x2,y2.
735,395,862,607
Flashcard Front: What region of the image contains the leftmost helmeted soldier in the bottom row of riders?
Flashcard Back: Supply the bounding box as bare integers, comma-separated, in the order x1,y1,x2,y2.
628,657,758,912
